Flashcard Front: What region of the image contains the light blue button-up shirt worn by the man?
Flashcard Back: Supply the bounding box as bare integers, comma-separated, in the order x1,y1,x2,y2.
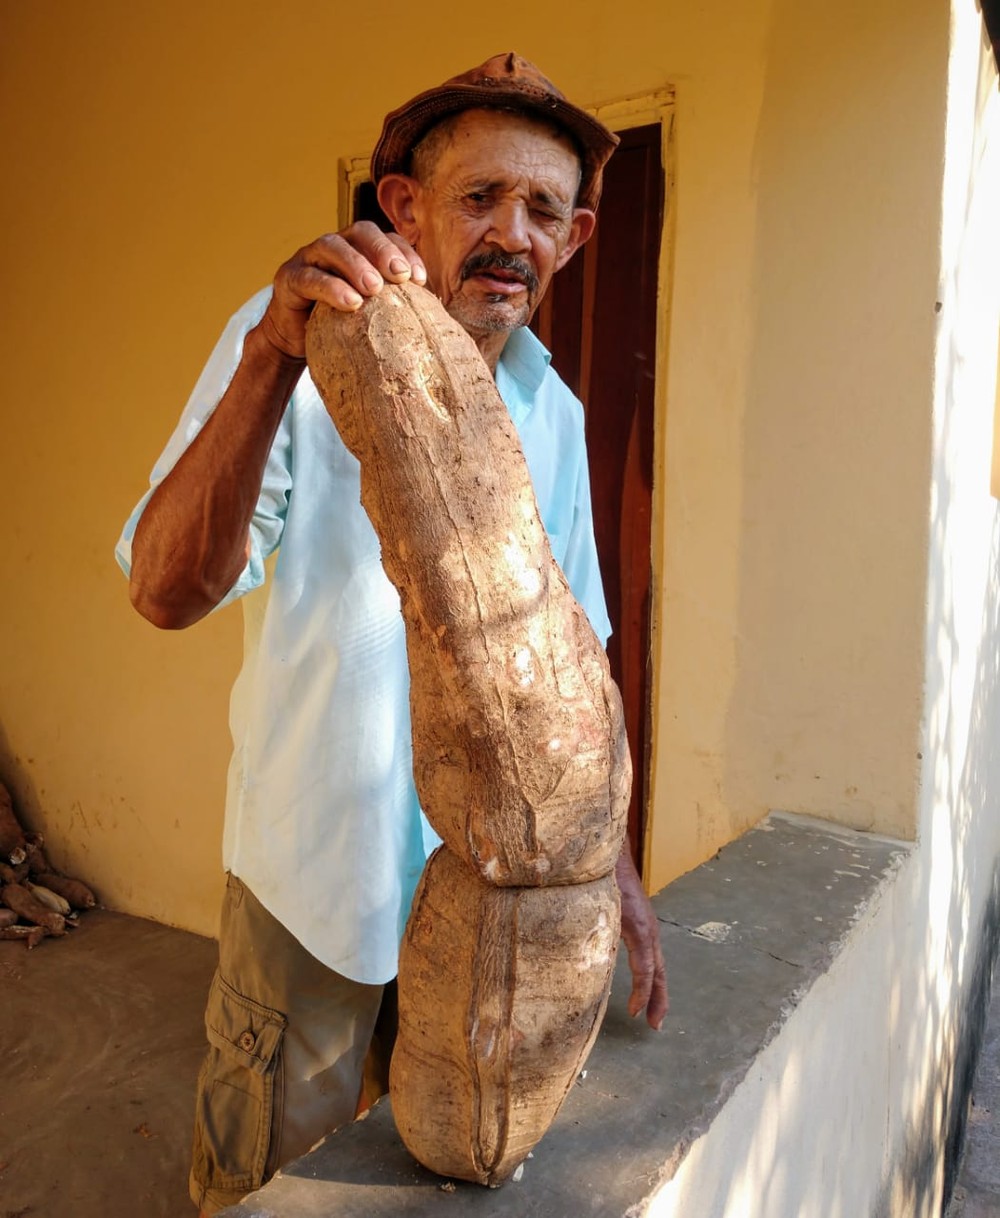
116,289,610,984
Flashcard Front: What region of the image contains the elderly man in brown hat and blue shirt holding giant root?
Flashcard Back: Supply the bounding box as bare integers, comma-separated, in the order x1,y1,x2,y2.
118,55,666,1214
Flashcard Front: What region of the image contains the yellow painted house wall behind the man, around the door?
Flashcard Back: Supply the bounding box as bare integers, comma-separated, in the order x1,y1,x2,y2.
0,0,946,932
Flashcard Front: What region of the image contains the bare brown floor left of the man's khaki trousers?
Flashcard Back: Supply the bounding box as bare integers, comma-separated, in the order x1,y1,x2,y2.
0,910,217,1218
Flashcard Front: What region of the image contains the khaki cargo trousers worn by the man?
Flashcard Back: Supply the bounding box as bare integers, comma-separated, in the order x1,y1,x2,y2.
190,876,395,1214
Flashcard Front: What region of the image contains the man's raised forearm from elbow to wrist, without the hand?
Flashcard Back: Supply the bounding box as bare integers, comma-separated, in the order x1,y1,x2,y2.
130,326,306,630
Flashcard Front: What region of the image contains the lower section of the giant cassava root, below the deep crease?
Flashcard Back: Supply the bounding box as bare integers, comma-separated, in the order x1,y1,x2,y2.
390,847,620,1185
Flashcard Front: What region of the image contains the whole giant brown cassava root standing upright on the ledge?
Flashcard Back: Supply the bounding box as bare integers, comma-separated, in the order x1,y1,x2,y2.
307,285,631,1185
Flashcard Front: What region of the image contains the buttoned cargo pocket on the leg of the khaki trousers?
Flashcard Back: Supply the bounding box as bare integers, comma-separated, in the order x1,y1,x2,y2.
191,973,286,1192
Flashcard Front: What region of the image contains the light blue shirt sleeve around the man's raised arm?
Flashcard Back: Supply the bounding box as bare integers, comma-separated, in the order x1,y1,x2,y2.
114,287,291,609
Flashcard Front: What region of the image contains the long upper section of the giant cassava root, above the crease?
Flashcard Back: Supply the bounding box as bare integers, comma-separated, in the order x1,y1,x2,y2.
306,284,631,885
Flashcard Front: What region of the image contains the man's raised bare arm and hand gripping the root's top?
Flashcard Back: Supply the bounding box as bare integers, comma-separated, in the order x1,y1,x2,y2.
130,223,426,630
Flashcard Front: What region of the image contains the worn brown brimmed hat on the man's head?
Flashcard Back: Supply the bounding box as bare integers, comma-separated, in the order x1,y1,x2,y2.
371,51,618,209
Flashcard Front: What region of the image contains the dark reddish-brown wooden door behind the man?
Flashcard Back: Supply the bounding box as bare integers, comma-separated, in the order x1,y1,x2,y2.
532,123,664,866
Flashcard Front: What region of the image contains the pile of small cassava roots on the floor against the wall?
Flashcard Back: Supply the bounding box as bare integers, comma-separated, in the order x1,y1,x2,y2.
0,783,96,948
